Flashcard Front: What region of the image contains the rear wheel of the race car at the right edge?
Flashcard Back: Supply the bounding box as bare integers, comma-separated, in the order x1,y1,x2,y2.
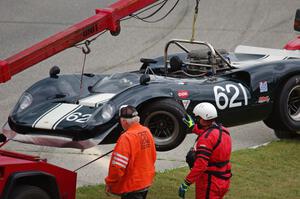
264,75,300,138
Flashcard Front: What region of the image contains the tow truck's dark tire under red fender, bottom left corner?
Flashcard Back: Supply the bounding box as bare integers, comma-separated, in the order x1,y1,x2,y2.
9,185,51,199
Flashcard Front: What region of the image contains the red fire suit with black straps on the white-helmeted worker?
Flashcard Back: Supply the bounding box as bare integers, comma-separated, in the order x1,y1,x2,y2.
185,124,231,199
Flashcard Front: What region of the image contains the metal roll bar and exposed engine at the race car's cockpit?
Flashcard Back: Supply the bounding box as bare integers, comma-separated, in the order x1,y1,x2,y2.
164,39,233,77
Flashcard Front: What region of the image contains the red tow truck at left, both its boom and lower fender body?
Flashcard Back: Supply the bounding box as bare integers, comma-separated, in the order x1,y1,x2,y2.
0,0,157,199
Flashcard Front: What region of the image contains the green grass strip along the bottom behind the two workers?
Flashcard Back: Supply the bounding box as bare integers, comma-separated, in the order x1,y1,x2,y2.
77,140,300,199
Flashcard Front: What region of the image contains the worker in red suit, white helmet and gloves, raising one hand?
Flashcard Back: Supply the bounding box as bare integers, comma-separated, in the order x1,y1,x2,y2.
178,102,231,199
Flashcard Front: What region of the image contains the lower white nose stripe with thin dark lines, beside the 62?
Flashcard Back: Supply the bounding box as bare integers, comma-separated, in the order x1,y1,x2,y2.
32,104,82,129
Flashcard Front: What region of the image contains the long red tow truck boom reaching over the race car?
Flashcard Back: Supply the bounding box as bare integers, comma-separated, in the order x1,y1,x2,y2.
0,0,157,83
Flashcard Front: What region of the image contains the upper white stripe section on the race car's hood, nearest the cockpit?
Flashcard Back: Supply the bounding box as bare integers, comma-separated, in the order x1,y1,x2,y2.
79,93,116,107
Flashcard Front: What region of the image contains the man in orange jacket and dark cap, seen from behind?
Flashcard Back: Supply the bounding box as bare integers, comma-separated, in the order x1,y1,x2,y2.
105,105,156,199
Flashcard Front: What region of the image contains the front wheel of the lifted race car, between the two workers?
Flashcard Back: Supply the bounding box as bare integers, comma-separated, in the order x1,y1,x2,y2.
140,99,187,151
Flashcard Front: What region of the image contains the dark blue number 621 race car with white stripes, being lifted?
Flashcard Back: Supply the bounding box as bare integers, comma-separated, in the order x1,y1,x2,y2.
4,40,300,151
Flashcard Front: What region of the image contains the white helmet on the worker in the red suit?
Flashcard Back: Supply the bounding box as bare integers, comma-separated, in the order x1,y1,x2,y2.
193,102,218,120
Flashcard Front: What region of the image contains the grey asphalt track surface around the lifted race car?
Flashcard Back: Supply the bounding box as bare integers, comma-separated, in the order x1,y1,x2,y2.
0,0,300,186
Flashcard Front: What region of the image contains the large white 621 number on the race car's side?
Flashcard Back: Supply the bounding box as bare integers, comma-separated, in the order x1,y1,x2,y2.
214,83,248,110
